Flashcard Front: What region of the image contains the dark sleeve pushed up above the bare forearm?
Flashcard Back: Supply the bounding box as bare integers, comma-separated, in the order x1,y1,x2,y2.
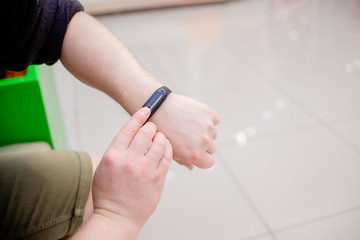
0,0,83,71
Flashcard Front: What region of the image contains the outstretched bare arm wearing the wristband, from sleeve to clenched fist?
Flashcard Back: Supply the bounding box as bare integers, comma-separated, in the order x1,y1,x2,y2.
60,12,219,168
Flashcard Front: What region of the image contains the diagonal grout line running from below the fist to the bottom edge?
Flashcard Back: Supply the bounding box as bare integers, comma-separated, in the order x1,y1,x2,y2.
217,154,278,240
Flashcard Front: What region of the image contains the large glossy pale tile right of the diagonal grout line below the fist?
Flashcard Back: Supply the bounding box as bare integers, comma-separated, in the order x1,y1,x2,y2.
218,128,360,230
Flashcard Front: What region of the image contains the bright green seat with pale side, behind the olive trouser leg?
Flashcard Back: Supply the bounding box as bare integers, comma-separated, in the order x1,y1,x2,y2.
0,65,67,150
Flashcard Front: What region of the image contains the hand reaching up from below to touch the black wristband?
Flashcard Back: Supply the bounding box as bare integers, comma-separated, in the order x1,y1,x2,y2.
92,108,172,229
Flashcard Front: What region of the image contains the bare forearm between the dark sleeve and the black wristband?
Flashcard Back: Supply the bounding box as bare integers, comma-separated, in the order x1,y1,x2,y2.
60,12,161,114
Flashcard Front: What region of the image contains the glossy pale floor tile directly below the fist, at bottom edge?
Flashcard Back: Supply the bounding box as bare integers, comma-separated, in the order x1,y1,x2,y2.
139,162,267,240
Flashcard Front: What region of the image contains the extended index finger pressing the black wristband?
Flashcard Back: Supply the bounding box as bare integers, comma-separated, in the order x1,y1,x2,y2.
110,107,150,151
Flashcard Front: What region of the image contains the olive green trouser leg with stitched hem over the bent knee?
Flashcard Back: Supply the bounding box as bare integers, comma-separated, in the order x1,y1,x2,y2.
0,143,92,240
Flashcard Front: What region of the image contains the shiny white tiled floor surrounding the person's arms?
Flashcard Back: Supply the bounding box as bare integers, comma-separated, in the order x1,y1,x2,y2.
55,0,360,240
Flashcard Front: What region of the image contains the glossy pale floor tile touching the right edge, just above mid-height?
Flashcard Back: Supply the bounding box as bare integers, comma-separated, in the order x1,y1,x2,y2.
279,71,360,123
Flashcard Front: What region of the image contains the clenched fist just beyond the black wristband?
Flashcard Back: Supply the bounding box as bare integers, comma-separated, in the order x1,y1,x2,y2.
151,93,219,169
